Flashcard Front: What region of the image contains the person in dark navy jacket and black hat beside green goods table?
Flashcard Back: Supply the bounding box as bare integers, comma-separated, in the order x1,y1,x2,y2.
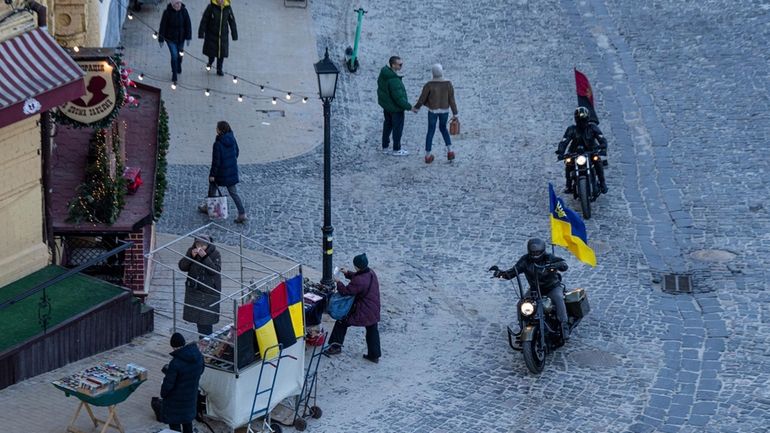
160,332,203,433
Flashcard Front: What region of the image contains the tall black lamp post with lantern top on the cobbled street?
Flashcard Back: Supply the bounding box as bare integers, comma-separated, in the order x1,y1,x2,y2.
314,48,340,287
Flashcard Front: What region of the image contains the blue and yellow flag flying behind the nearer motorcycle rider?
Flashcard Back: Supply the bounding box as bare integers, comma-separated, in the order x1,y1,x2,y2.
548,183,596,266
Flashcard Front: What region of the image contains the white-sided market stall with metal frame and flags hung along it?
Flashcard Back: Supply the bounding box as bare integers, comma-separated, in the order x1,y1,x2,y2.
148,223,323,430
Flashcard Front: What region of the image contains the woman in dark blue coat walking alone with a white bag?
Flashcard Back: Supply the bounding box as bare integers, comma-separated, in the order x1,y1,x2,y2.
198,120,248,224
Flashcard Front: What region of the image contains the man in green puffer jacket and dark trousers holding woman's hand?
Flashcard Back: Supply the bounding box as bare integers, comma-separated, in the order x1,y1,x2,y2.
377,56,412,156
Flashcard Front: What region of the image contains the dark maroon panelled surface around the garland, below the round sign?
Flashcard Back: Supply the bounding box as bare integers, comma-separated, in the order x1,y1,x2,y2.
50,84,161,235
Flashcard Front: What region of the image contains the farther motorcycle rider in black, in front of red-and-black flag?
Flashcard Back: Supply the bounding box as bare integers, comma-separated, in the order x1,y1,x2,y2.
556,107,607,194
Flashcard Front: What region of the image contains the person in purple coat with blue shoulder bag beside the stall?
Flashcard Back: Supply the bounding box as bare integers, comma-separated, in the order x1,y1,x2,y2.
325,254,382,363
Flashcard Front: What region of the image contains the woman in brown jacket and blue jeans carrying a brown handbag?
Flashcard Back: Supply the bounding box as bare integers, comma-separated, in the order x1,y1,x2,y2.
412,63,457,164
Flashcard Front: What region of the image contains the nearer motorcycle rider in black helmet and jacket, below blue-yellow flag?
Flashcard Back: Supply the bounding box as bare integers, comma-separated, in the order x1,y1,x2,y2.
489,238,569,341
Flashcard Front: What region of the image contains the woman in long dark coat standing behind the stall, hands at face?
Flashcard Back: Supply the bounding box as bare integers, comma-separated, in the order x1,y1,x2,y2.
179,235,222,336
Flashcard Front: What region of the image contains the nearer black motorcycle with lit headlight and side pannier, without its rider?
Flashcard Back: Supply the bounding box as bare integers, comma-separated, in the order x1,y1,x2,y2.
489,264,591,374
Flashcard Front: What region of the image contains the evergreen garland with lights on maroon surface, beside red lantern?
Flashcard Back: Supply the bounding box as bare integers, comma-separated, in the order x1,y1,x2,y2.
67,128,126,225
